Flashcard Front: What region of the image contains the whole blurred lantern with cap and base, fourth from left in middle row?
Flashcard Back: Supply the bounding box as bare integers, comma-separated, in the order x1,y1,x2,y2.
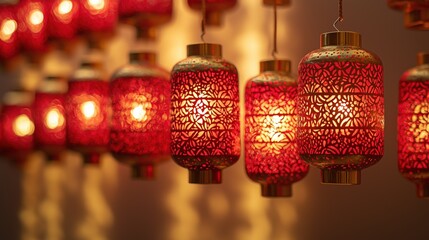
110,53,171,179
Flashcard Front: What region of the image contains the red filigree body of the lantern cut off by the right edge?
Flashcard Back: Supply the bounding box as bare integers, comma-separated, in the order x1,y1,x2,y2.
398,81,429,180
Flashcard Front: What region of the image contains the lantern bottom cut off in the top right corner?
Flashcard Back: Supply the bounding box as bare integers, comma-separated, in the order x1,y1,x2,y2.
387,0,429,30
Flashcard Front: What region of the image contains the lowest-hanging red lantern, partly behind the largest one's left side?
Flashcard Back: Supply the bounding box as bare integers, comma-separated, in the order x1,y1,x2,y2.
244,60,308,197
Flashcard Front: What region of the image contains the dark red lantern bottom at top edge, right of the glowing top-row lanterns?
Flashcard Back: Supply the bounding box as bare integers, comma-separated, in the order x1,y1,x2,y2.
119,0,173,39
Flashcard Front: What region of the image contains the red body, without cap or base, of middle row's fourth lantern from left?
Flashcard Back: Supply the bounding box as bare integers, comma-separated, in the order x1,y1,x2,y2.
110,77,170,164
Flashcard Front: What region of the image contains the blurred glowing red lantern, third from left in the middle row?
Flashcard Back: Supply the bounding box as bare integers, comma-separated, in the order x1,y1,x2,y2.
66,61,110,164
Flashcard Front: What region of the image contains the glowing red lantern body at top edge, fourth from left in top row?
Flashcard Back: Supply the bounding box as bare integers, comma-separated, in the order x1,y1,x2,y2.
79,0,118,32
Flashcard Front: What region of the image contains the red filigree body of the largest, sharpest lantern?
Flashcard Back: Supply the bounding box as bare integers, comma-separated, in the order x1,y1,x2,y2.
298,61,384,170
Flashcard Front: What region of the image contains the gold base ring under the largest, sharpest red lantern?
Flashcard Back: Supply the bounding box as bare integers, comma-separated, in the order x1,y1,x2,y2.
321,169,360,185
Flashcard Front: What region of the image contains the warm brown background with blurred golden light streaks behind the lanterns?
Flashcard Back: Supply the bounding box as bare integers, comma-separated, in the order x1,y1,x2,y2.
0,0,429,240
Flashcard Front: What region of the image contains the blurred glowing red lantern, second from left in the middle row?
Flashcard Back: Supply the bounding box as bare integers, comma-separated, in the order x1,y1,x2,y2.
33,76,67,160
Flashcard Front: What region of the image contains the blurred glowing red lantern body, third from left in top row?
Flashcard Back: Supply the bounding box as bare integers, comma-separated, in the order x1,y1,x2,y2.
48,0,79,38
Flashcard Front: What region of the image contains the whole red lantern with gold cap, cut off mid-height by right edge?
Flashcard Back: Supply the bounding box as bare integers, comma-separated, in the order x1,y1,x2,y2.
398,53,429,198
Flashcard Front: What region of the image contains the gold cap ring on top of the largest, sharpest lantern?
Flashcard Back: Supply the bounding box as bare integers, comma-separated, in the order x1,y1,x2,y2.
320,31,362,47
